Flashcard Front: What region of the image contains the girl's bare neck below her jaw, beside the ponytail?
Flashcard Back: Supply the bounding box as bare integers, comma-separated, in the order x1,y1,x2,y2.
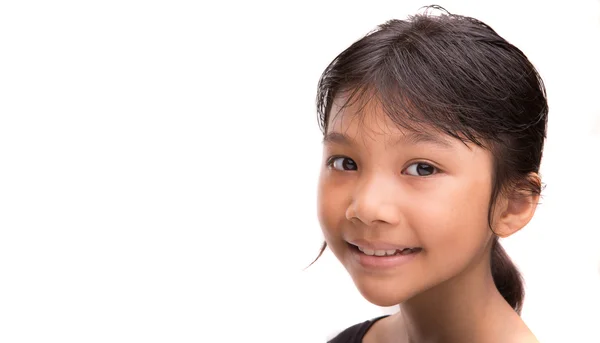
398,251,522,343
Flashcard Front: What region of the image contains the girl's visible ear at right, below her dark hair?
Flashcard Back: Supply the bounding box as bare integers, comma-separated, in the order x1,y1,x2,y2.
494,173,541,238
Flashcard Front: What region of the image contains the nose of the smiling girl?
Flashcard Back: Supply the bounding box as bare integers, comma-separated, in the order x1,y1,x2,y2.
346,176,401,226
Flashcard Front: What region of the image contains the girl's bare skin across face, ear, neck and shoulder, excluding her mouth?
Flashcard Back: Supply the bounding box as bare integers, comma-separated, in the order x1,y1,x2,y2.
318,99,538,343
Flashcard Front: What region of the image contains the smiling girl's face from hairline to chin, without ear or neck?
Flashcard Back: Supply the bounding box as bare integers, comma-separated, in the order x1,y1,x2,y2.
318,99,493,306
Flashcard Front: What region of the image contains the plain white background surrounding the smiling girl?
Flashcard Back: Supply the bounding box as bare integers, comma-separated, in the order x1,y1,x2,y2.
0,0,600,343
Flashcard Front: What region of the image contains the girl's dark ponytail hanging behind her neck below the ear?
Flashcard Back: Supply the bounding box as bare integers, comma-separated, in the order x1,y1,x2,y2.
491,237,525,314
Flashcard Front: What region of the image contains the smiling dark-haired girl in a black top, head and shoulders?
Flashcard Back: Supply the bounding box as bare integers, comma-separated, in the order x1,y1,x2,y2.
317,6,548,343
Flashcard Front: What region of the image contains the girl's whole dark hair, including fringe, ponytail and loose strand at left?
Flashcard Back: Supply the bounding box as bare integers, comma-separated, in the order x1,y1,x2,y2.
313,6,548,313
